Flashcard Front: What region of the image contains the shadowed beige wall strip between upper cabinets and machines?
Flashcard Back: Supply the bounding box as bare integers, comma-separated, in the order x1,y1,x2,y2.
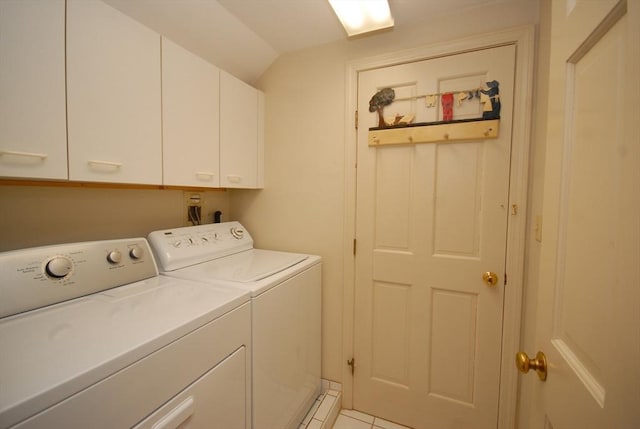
0,186,230,251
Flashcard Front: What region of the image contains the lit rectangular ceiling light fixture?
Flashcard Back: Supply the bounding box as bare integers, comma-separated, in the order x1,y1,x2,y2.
329,0,393,37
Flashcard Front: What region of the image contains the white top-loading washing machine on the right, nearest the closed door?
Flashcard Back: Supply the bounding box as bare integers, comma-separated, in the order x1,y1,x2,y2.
148,222,321,429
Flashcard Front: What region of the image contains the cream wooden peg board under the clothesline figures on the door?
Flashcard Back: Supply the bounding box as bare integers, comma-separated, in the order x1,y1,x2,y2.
369,119,500,146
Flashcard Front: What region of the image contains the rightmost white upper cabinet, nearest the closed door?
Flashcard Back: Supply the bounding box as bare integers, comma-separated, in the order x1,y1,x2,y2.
220,71,264,188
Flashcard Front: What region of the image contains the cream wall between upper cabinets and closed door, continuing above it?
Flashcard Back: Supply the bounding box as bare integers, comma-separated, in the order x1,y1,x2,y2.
231,0,538,381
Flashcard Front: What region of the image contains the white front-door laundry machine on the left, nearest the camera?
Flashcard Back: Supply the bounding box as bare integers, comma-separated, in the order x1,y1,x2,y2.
0,238,251,429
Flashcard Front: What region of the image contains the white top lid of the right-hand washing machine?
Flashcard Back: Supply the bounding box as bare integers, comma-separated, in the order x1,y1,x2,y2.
200,249,309,283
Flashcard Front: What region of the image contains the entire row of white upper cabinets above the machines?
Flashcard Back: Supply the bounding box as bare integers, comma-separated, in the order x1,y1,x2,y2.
0,0,264,188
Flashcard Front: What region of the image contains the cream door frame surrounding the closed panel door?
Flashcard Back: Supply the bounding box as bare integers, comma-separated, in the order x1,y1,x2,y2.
342,25,535,429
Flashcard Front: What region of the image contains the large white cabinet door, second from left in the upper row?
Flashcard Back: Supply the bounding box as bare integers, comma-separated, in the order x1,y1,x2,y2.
67,0,162,184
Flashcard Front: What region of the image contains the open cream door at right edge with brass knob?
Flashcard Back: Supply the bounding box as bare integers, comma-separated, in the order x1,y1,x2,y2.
526,0,640,429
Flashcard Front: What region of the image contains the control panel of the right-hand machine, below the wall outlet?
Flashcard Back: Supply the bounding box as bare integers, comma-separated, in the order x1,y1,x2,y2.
148,222,253,271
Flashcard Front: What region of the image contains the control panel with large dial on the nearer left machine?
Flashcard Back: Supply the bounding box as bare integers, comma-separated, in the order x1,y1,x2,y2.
0,238,158,317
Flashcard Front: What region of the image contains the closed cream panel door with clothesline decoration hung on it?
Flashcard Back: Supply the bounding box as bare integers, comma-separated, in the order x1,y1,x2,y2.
353,45,516,429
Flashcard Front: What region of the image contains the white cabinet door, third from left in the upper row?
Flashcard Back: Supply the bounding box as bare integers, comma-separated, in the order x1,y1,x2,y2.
162,38,220,187
